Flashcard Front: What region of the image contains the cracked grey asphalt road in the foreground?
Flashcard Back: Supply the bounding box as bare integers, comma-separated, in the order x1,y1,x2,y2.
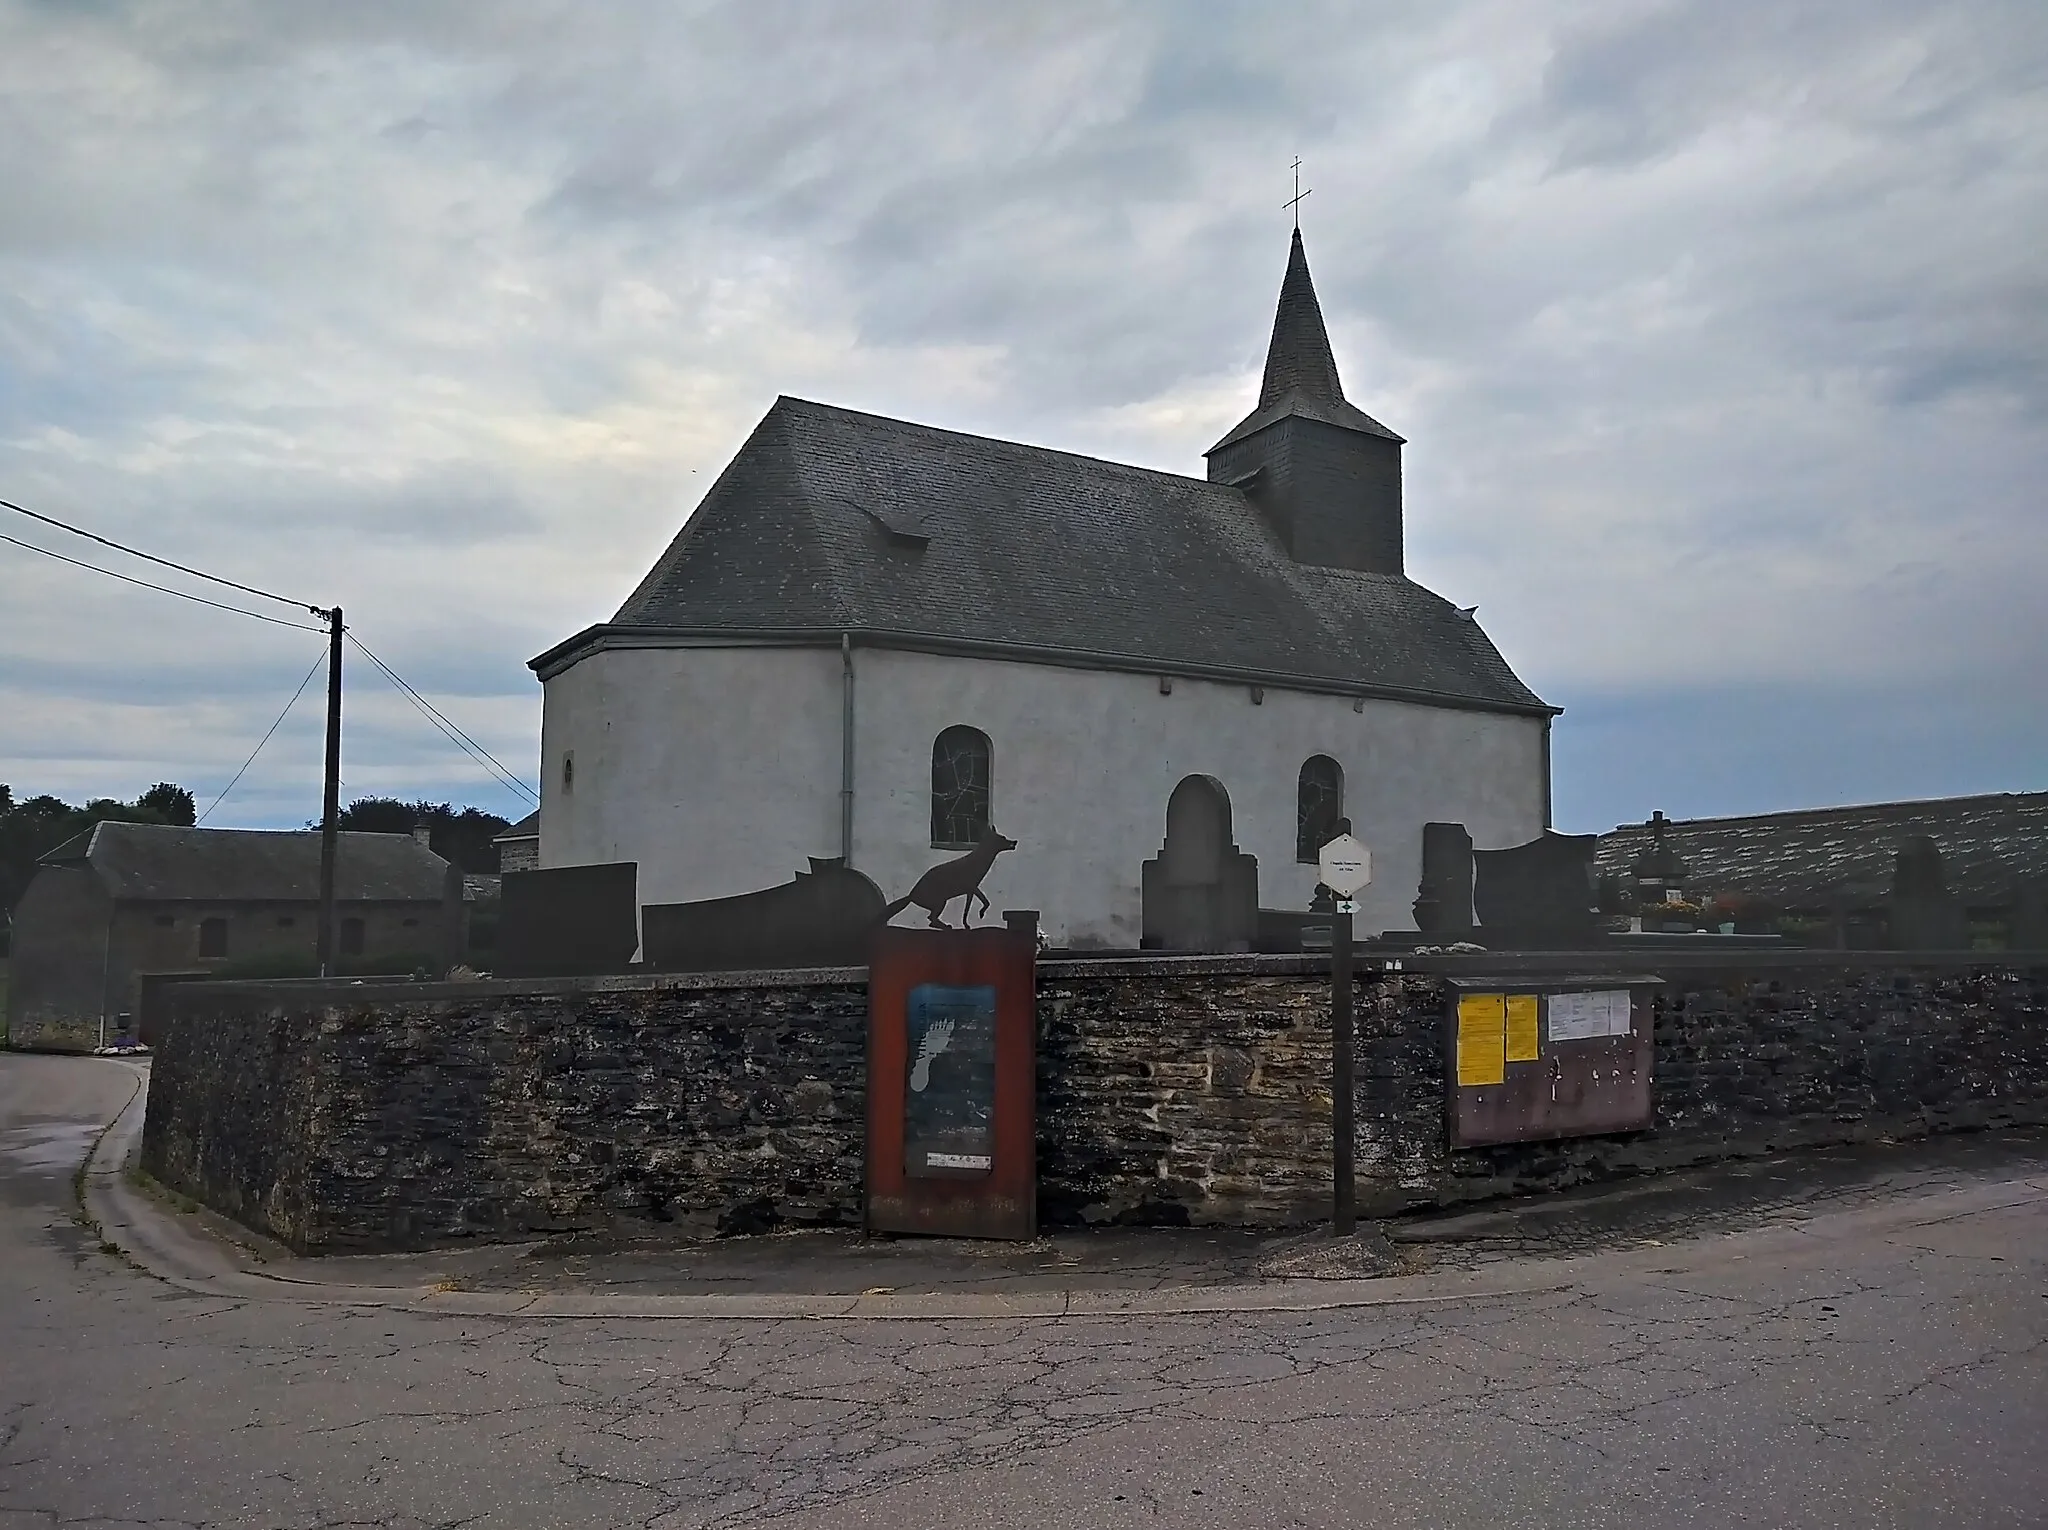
0,1055,2048,1530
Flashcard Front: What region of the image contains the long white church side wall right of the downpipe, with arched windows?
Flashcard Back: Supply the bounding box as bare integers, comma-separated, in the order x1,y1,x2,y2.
854,649,1544,946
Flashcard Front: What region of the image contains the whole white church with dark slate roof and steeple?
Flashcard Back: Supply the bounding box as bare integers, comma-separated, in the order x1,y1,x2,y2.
532,229,1556,950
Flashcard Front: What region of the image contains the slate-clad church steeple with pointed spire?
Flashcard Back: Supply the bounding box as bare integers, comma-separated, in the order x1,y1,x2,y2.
1206,227,1403,573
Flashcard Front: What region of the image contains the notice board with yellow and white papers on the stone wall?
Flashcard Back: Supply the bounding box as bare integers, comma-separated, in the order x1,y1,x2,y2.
1444,975,1657,1147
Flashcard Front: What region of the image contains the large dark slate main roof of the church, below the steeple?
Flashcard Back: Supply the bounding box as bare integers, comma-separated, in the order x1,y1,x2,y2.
532,397,1554,713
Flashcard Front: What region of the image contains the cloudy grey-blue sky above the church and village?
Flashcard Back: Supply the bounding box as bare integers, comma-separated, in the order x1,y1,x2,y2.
0,0,2048,830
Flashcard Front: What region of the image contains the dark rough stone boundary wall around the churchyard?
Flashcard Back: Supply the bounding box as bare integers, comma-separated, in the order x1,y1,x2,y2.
143,952,2048,1251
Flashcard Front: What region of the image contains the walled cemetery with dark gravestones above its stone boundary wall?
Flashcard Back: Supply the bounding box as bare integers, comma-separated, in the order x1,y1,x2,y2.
143,825,2048,1251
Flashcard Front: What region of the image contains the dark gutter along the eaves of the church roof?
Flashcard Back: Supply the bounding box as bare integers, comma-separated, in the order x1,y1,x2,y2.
526,625,1565,717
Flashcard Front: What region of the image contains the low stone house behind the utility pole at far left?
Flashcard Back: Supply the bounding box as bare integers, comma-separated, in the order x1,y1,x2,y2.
8,823,463,1051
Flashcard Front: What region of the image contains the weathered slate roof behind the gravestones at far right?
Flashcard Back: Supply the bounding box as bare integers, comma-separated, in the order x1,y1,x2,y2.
1597,791,2048,907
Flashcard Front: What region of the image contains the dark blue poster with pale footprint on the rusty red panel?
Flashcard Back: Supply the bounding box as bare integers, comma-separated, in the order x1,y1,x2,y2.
903,983,995,1176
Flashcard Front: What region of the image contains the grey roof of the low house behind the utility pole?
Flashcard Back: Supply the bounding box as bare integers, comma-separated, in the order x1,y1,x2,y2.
41,823,449,903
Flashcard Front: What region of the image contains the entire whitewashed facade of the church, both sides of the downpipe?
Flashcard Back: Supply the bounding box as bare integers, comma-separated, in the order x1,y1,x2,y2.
541,647,1548,948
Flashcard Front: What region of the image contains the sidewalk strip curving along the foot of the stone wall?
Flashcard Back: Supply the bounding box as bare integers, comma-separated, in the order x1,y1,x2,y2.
84,1061,2048,1319
